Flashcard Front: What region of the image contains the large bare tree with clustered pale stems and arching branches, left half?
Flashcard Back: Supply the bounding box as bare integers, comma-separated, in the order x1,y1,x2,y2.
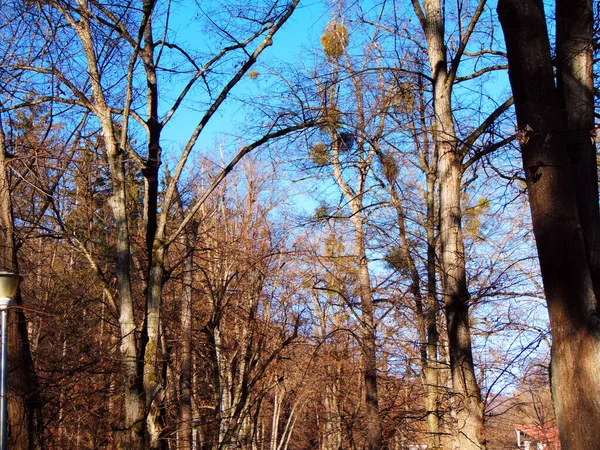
12,1,304,448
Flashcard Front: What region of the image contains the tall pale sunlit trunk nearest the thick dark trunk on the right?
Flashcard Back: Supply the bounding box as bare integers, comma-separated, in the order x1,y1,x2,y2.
413,0,485,450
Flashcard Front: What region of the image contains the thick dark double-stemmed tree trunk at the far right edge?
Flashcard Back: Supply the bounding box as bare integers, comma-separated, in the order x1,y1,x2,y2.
498,0,600,450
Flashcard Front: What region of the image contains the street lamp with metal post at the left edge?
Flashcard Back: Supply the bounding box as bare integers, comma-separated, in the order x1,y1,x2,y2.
0,272,21,450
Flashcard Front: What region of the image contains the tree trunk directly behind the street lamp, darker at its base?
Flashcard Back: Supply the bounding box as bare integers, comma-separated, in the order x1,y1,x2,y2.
0,118,43,450
